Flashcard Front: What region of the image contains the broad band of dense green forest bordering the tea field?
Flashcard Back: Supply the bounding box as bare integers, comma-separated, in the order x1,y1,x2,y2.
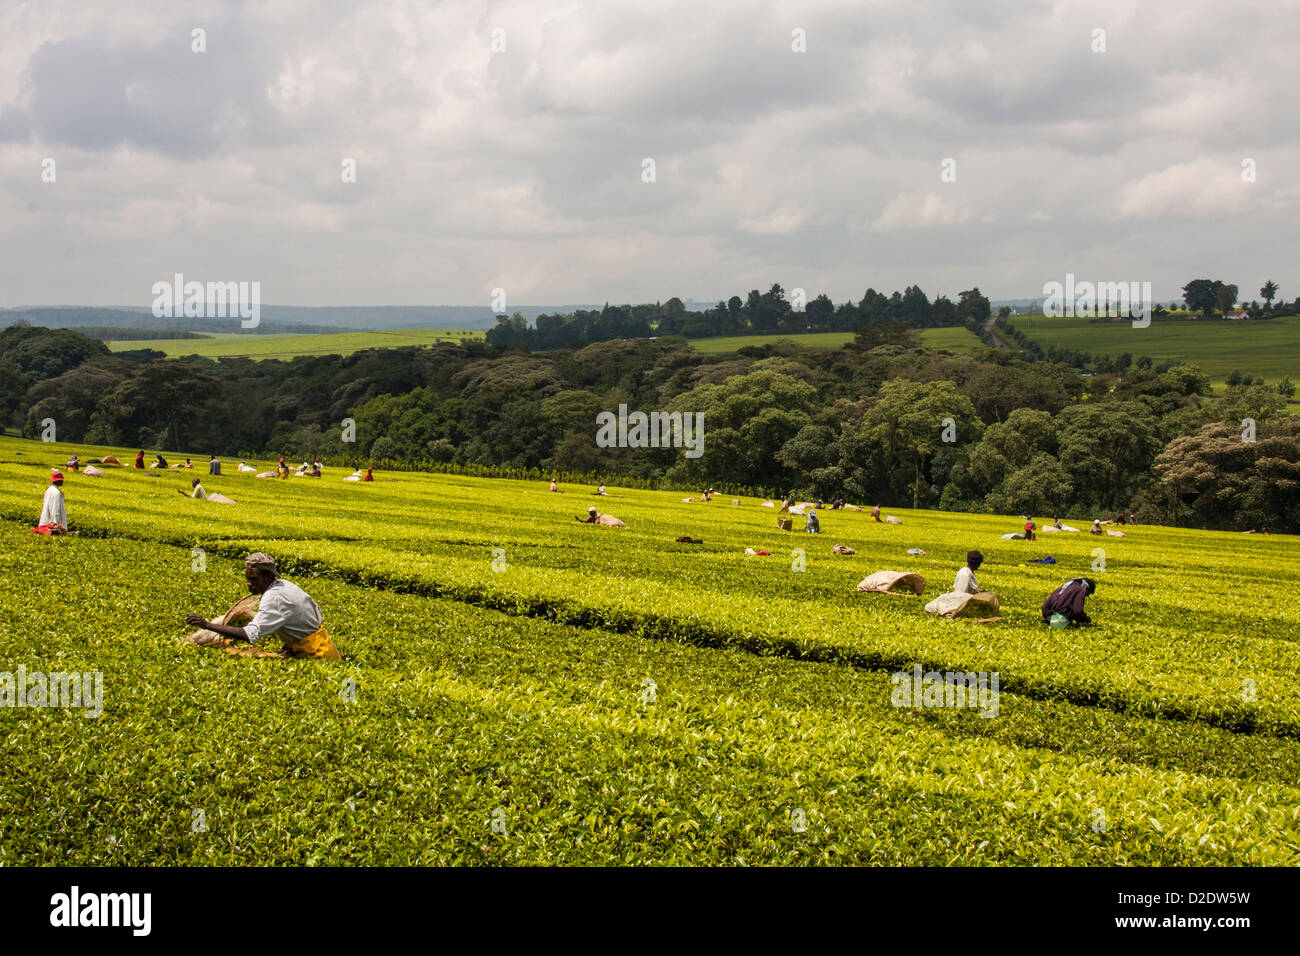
0,321,1300,532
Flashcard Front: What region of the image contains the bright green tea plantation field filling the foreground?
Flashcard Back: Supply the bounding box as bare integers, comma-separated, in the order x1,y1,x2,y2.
0,438,1300,866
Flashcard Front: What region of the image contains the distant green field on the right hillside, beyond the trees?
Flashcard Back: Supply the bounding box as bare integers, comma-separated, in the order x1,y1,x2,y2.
1011,315,1300,384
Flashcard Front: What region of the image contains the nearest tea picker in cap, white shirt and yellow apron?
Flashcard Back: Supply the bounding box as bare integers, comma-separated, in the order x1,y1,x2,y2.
185,551,342,661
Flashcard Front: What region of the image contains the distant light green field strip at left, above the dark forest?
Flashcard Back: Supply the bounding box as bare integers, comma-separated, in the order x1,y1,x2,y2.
108,329,484,359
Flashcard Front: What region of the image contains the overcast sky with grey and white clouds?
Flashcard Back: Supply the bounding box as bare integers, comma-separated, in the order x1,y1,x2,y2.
0,0,1300,306
